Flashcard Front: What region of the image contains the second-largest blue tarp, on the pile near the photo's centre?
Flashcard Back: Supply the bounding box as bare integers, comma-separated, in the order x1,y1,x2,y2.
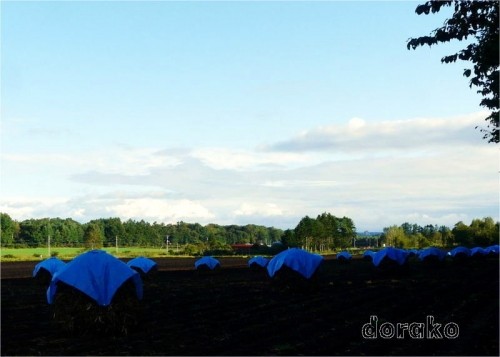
267,248,324,279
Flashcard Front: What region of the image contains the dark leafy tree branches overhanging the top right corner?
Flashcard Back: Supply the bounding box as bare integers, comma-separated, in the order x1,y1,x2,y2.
407,0,500,143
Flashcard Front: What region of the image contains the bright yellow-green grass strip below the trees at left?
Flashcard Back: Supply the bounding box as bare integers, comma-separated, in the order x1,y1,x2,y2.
0,247,189,261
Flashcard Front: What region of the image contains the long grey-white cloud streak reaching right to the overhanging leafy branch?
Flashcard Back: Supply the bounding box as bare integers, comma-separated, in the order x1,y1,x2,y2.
262,111,488,153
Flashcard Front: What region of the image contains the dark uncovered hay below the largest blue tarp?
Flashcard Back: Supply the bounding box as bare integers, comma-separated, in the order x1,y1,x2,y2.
53,279,142,336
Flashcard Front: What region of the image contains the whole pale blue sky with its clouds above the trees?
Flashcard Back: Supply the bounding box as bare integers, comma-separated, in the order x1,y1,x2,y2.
0,1,499,231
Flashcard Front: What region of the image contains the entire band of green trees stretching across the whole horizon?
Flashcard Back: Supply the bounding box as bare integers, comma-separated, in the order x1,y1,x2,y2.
0,212,499,255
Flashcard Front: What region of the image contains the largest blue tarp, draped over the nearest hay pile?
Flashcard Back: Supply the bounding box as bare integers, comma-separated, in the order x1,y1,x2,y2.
47,250,142,306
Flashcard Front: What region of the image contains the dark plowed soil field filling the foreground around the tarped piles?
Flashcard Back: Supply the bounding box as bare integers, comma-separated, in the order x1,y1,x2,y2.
1,257,499,356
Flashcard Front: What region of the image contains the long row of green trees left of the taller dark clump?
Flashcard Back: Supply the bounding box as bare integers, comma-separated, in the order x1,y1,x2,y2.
0,213,283,248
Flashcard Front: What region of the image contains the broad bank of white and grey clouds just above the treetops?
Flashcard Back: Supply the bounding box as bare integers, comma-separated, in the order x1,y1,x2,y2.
0,113,498,231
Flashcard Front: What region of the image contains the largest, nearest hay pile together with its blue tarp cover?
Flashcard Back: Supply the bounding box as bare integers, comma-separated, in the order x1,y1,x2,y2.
47,250,143,335
